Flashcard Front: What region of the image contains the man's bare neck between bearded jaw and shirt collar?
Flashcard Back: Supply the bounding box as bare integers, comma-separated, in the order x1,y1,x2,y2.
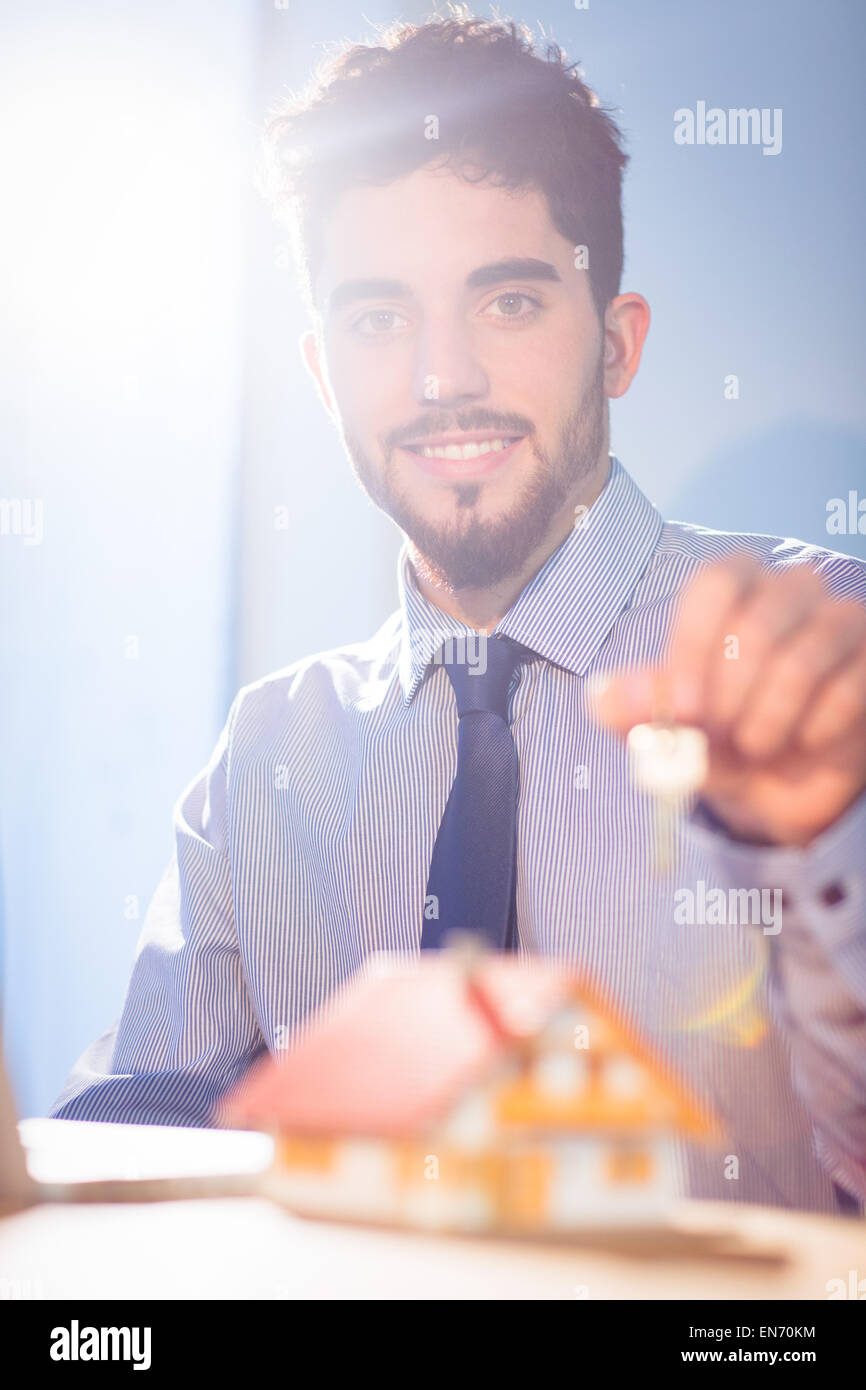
410,446,610,632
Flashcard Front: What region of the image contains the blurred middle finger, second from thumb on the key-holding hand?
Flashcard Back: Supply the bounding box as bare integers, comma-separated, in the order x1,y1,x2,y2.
708,566,827,734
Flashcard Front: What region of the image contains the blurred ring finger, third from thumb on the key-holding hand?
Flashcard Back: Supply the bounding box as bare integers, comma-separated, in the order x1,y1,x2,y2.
730,603,866,759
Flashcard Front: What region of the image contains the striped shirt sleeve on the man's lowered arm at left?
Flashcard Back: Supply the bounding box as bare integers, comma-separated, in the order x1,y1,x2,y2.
50,701,265,1126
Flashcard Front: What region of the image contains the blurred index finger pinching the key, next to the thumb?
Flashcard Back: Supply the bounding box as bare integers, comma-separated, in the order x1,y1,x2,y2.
666,555,760,724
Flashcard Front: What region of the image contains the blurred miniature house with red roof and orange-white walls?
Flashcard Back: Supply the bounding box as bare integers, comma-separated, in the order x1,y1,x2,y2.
227,948,710,1233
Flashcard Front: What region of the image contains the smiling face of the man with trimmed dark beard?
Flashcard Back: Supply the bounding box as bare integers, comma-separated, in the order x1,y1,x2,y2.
308,167,606,588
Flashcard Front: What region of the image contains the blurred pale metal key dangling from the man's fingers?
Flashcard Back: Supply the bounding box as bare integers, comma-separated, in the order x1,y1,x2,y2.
628,720,709,873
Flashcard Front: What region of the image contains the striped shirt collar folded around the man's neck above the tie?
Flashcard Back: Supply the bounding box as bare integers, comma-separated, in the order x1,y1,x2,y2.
398,455,663,702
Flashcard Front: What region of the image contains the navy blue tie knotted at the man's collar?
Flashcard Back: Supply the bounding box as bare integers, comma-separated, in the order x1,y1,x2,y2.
421,637,530,951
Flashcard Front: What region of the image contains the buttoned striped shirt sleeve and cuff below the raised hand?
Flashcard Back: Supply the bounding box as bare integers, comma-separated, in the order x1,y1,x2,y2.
689,795,866,1201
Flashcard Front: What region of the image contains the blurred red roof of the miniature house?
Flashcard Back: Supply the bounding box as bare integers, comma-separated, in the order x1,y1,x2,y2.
225,951,711,1138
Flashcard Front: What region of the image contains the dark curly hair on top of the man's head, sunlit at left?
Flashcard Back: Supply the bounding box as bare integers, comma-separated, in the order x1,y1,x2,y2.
263,17,627,314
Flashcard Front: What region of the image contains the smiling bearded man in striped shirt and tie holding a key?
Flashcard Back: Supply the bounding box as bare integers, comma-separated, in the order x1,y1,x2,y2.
54,19,866,1211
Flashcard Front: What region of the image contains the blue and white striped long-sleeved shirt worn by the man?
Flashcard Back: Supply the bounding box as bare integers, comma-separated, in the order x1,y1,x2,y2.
53,457,866,1211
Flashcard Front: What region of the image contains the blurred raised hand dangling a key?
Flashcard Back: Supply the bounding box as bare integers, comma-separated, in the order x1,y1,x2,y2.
595,555,866,845
